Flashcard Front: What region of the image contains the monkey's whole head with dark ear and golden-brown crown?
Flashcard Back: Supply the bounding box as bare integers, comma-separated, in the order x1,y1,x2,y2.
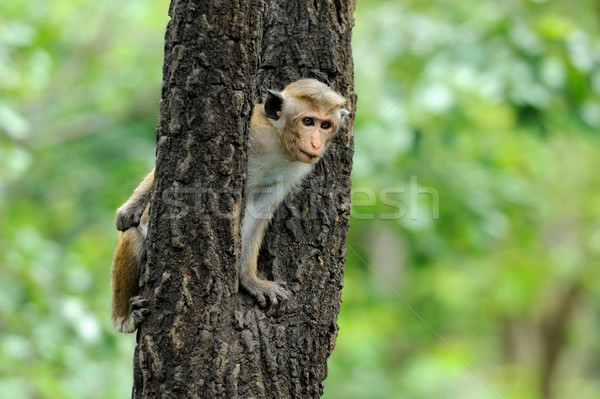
265,79,349,164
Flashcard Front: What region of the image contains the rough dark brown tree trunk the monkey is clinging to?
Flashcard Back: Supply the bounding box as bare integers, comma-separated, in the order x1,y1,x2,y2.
132,0,355,398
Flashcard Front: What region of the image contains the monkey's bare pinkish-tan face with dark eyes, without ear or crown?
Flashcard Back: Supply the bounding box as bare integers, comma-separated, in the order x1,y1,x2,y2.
293,111,336,163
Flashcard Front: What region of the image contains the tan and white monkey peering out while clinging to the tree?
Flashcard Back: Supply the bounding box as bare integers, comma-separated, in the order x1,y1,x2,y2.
111,79,349,332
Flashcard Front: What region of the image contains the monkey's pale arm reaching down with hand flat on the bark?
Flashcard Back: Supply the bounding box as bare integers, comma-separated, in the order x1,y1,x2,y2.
239,193,289,312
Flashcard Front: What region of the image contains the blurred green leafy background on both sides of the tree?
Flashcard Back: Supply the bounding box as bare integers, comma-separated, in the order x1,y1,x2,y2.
0,0,600,399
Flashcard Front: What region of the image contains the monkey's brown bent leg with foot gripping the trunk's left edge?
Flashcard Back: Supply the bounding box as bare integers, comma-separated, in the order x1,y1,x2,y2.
111,227,149,333
